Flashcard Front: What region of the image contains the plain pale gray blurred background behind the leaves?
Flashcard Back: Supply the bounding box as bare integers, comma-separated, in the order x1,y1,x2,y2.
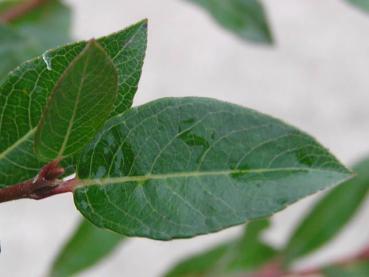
0,0,369,277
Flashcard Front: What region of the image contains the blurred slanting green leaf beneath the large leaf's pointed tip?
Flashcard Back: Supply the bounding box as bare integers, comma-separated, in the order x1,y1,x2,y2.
285,156,369,263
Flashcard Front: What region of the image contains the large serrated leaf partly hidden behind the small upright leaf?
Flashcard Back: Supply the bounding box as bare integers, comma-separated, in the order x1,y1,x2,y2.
0,20,147,187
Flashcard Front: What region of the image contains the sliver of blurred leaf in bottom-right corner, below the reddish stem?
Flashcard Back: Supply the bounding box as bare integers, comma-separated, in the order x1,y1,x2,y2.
323,261,369,277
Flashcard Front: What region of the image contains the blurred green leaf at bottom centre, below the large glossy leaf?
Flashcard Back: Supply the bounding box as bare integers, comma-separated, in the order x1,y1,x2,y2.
166,220,276,277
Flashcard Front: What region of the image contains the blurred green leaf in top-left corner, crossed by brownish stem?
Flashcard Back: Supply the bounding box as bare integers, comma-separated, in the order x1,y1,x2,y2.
0,0,71,79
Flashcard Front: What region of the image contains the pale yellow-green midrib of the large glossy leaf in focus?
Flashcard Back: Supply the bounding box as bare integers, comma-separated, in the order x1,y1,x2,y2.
80,167,351,186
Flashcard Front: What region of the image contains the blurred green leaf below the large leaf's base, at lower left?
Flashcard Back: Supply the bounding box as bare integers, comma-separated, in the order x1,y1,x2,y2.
49,220,125,277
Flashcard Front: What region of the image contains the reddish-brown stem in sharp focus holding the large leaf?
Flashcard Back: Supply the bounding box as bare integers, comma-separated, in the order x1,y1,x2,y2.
0,161,79,203
